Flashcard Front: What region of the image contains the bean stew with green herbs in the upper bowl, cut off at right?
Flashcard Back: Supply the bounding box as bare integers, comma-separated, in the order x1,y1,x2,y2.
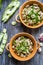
22,4,43,26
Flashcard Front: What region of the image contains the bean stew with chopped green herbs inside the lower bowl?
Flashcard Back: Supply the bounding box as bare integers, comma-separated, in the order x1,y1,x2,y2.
12,36,33,57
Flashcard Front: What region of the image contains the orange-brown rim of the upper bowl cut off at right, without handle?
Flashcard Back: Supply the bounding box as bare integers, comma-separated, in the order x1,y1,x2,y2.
19,1,43,29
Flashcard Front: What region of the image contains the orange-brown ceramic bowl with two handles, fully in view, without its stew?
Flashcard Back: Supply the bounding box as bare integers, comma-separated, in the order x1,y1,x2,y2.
6,32,40,61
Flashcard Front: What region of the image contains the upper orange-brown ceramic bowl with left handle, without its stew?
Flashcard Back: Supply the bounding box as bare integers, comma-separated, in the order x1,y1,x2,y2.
16,0,43,28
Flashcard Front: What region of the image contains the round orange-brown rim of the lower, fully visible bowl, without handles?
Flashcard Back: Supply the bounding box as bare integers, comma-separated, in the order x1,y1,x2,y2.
9,32,37,61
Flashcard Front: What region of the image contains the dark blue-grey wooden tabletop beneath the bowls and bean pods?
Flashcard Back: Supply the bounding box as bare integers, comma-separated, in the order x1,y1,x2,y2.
0,0,43,65
